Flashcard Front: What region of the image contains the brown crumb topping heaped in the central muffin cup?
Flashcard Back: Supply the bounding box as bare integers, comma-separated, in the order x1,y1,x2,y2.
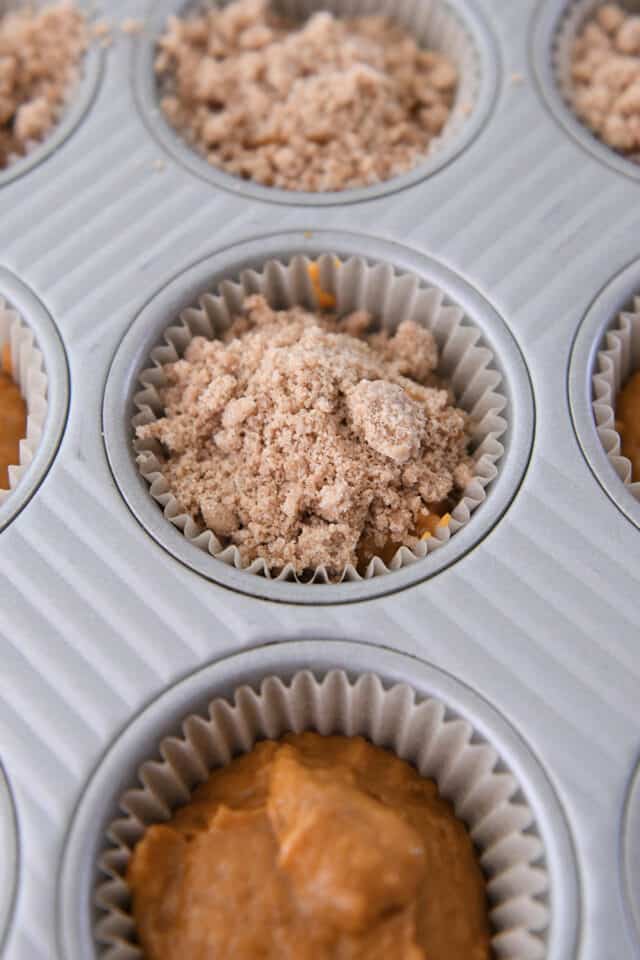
136,296,472,576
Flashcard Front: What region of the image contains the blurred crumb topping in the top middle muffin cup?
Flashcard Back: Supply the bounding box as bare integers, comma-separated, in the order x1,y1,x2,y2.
156,0,458,192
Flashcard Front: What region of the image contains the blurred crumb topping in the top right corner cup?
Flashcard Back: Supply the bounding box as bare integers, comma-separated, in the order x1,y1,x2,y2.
571,3,640,162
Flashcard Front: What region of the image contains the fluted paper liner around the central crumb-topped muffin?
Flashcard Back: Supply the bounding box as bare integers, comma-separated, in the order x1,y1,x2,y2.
132,254,507,583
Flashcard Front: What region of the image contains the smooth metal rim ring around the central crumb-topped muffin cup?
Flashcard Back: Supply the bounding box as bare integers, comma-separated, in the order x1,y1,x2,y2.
102,231,534,604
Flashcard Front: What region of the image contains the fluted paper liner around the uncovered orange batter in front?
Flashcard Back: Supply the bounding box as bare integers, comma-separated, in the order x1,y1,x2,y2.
95,670,549,960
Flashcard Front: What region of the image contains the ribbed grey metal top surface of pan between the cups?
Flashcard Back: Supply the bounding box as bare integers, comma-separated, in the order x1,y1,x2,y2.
0,0,640,960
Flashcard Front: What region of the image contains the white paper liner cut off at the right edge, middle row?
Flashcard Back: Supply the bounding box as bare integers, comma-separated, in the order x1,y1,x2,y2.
593,297,640,501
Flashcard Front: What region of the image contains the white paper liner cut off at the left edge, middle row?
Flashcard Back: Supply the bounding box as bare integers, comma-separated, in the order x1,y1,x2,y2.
0,297,48,504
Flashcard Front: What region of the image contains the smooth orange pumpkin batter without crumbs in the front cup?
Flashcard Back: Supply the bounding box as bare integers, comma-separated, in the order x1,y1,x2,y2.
127,733,491,960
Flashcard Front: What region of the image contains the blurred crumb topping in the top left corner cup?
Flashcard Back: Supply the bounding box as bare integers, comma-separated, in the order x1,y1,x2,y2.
0,2,87,167
